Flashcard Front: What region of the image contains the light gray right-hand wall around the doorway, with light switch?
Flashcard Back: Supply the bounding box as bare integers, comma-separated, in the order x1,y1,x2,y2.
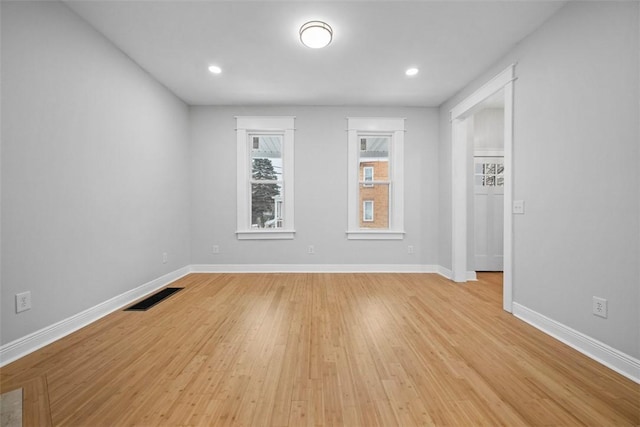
439,2,640,358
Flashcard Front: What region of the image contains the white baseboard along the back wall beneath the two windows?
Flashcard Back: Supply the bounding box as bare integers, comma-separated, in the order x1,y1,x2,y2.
191,264,439,273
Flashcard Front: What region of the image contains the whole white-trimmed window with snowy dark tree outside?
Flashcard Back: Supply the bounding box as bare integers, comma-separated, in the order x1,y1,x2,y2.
236,116,295,239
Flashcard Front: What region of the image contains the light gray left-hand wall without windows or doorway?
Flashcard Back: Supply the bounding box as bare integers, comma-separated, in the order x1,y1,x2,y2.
1,2,189,344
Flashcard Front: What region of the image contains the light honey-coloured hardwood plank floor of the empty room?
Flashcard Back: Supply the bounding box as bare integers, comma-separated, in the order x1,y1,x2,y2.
0,274,640,426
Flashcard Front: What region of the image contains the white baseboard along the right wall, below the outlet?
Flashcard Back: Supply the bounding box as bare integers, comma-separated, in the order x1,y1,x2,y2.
513,302,640,384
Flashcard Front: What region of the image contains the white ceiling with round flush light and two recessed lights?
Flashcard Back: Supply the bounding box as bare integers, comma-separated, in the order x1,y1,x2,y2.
66,0,564,106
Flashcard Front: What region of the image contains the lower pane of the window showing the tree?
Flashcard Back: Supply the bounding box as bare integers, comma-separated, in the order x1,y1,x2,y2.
251,183,283,228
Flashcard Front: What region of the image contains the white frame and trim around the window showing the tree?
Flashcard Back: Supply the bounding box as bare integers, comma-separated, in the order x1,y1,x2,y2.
236,116,295,240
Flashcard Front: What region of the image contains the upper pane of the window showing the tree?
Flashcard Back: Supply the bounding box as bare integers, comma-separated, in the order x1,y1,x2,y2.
251,135,283,181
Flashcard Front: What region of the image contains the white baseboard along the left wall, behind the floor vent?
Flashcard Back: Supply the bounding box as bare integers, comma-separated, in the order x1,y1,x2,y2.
0,266,191,366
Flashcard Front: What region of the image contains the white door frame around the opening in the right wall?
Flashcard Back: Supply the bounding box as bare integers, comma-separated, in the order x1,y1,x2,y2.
450,64,515,312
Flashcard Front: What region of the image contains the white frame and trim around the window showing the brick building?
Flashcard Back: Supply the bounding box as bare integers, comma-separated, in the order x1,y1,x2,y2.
347,117,405,240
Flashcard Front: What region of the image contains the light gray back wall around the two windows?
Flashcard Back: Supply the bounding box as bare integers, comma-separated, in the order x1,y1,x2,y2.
191,107,438,264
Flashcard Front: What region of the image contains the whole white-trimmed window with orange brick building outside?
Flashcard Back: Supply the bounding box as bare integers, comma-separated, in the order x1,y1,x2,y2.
347,118,404,240
